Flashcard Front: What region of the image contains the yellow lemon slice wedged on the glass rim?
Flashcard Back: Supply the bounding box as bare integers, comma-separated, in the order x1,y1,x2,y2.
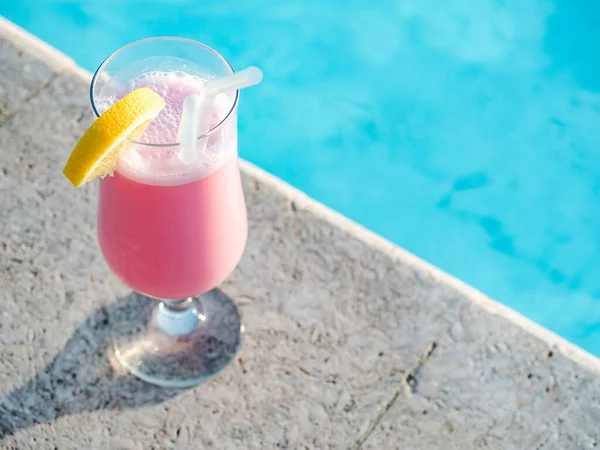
63,88,165,187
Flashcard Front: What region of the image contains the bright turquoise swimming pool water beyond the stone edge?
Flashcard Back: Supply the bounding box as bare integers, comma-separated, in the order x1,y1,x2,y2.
0,0,600,355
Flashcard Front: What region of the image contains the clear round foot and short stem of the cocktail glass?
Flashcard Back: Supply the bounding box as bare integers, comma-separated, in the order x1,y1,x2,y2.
112,289,244,388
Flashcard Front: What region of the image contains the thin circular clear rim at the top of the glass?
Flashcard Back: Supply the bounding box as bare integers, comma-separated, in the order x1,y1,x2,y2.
90,36,240,148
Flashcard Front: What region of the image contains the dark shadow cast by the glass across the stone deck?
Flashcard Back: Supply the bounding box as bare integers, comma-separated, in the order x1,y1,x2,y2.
0,293,183,439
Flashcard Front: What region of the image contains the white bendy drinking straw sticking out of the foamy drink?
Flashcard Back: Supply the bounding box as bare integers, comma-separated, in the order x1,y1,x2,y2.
178,67,262,164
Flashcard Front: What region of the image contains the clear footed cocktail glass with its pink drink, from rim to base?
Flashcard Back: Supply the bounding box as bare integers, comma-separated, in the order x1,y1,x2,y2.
90,38,248,387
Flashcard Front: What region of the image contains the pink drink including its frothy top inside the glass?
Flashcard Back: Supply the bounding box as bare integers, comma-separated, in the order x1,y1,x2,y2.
98,73,248,299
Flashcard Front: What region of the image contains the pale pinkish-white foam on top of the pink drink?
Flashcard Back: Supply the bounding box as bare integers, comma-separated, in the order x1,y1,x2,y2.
98,71,237,185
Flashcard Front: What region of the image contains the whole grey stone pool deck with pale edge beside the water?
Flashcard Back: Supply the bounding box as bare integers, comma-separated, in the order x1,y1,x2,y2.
0,15,600,449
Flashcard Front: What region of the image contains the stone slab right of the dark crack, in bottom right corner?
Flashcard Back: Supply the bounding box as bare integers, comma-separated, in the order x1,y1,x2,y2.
363,303,600,449
